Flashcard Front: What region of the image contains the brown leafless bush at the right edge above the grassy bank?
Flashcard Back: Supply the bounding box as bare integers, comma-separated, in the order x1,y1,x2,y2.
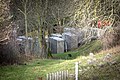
103,23,120,49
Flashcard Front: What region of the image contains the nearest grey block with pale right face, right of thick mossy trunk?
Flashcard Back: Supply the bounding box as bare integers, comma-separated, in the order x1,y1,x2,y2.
49,37,64,53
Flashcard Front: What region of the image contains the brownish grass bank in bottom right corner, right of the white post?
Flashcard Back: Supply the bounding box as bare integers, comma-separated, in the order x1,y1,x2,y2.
79,55,120,80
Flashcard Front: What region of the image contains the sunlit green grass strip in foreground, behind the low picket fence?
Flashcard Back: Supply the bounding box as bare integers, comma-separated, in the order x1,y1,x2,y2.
0,56,105,80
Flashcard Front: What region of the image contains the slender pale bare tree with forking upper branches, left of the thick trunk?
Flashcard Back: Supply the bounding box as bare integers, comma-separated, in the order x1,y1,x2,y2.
17,0,32,55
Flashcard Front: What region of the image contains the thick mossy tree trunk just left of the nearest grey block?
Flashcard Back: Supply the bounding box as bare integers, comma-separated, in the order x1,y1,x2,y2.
30,0,48,58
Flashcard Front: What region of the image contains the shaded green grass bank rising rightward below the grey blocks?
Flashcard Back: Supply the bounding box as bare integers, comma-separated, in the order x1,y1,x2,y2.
53,40,102,59
